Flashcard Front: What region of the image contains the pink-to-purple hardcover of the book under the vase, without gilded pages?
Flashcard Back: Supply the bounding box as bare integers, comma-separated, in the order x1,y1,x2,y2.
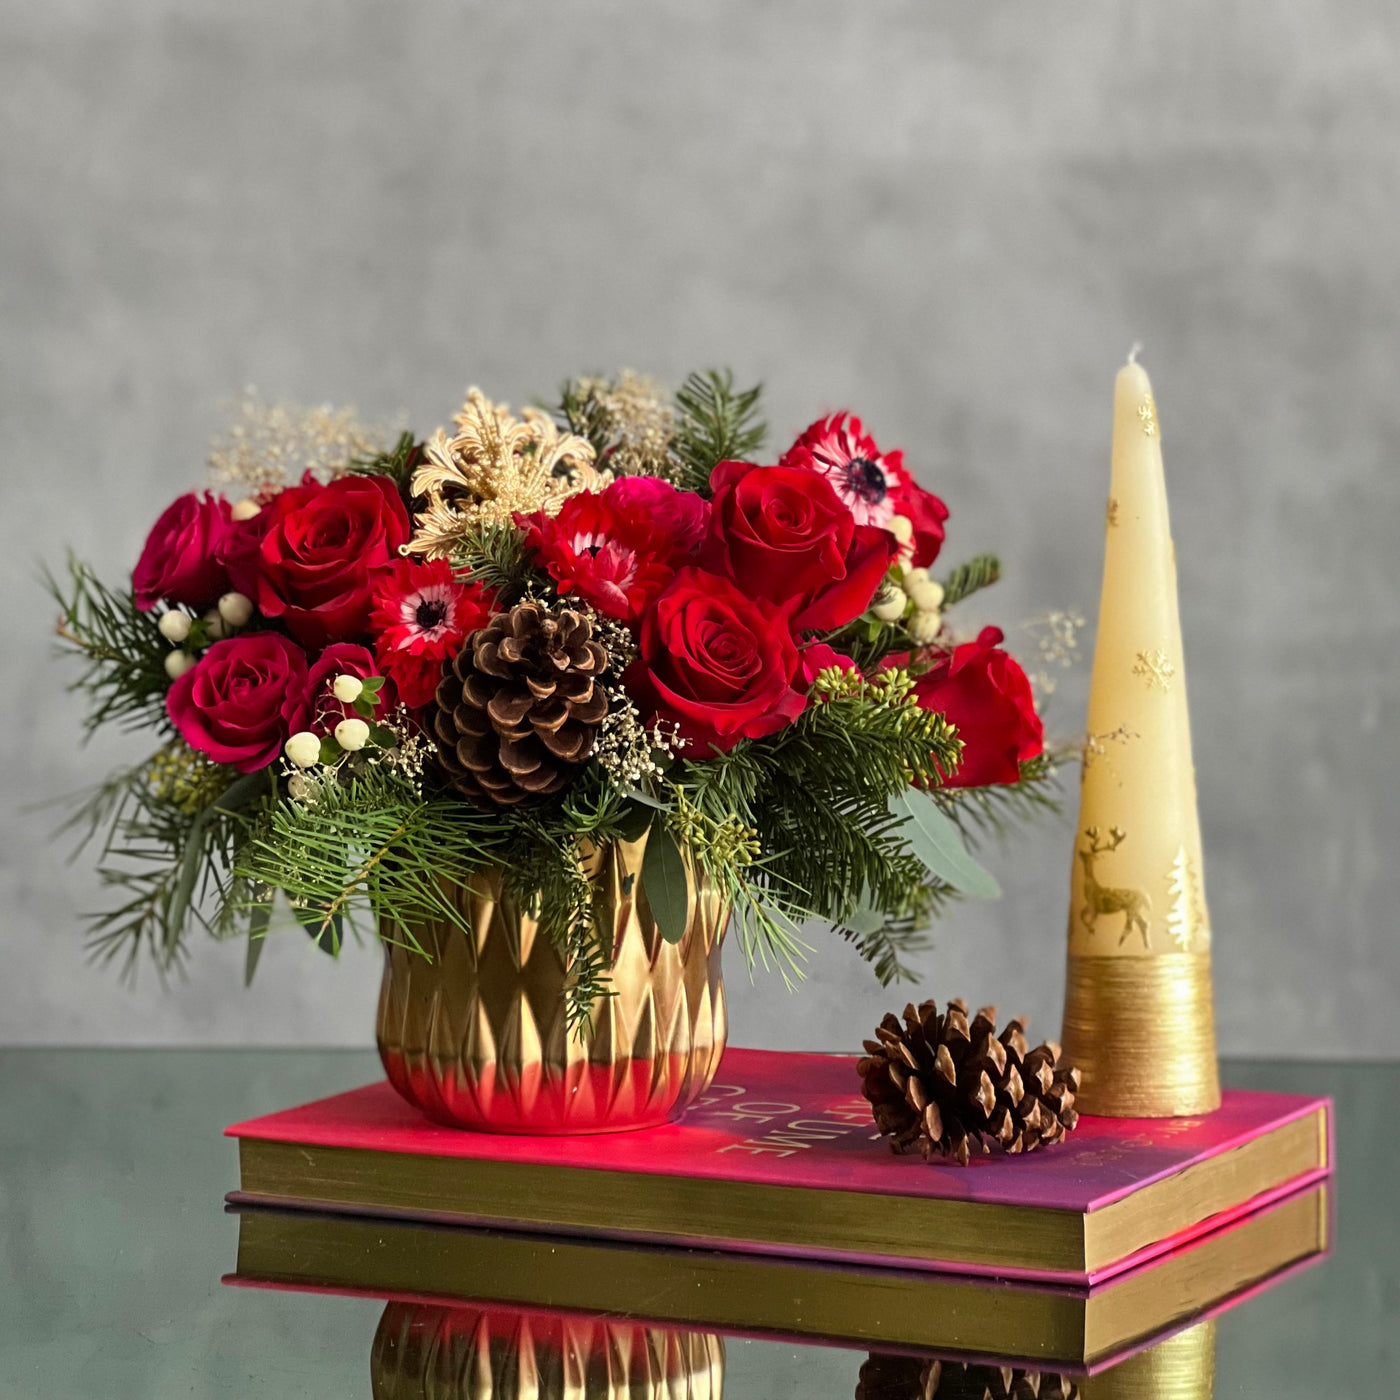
225,1049,1333,1284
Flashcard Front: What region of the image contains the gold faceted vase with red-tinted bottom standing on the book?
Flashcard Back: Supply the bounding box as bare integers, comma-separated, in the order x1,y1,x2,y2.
375,836,729,1133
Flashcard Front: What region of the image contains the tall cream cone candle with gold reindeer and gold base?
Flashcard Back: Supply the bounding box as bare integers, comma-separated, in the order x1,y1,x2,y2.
1064,357,1219,1117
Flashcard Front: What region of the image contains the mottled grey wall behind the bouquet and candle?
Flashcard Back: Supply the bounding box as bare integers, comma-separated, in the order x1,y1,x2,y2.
0,0,1400,1054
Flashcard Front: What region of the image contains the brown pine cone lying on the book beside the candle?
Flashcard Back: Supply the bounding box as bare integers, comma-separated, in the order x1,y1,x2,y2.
857,1001,1079,1166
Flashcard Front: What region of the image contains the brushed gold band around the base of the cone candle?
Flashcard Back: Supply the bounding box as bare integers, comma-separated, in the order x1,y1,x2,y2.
1063,953,1221,1119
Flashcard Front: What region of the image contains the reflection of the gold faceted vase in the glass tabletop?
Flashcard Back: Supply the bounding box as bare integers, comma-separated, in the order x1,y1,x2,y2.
370,1302,724,1400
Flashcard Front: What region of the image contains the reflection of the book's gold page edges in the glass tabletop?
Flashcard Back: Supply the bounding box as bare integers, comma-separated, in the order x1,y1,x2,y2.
235,1183,1329,1365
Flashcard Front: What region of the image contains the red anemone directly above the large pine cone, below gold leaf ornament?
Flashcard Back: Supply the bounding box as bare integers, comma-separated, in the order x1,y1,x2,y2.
515,491,683,622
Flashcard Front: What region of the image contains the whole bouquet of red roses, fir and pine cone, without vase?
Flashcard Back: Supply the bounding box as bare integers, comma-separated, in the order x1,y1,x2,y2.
52,372,1053,1023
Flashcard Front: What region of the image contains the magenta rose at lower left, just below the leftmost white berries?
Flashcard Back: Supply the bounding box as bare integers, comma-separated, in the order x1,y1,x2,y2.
165,631,307,773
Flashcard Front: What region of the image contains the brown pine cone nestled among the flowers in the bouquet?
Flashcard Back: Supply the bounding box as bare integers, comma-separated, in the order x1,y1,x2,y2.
433,602,608,806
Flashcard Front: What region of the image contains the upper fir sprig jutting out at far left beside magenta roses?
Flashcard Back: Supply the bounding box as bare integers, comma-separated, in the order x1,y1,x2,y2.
43,554,171,736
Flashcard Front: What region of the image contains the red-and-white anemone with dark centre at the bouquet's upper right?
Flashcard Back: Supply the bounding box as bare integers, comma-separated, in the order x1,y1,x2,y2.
783,413,948,568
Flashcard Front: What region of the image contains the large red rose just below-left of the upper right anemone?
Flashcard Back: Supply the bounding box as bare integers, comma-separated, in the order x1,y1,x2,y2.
704,462,896,631
